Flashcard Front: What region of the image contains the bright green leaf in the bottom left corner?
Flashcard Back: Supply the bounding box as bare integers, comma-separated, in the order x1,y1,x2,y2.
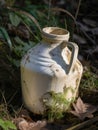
0,119,17,130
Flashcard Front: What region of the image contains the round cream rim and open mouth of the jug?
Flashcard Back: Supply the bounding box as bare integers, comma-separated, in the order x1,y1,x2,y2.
42,27,69,41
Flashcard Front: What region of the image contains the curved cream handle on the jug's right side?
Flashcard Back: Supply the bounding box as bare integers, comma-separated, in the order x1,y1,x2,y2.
67,42,78,74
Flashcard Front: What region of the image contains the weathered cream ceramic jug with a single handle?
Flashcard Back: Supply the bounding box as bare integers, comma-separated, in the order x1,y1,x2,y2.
21,27,83,114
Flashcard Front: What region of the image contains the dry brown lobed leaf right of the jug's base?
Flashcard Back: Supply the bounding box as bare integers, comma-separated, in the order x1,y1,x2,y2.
70,97,98,120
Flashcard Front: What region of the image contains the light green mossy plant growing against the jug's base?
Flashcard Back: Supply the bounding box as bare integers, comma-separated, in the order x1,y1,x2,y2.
43,91,72,121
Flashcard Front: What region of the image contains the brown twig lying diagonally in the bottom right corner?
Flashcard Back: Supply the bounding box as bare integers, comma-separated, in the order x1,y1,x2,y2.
66,116,98,130
